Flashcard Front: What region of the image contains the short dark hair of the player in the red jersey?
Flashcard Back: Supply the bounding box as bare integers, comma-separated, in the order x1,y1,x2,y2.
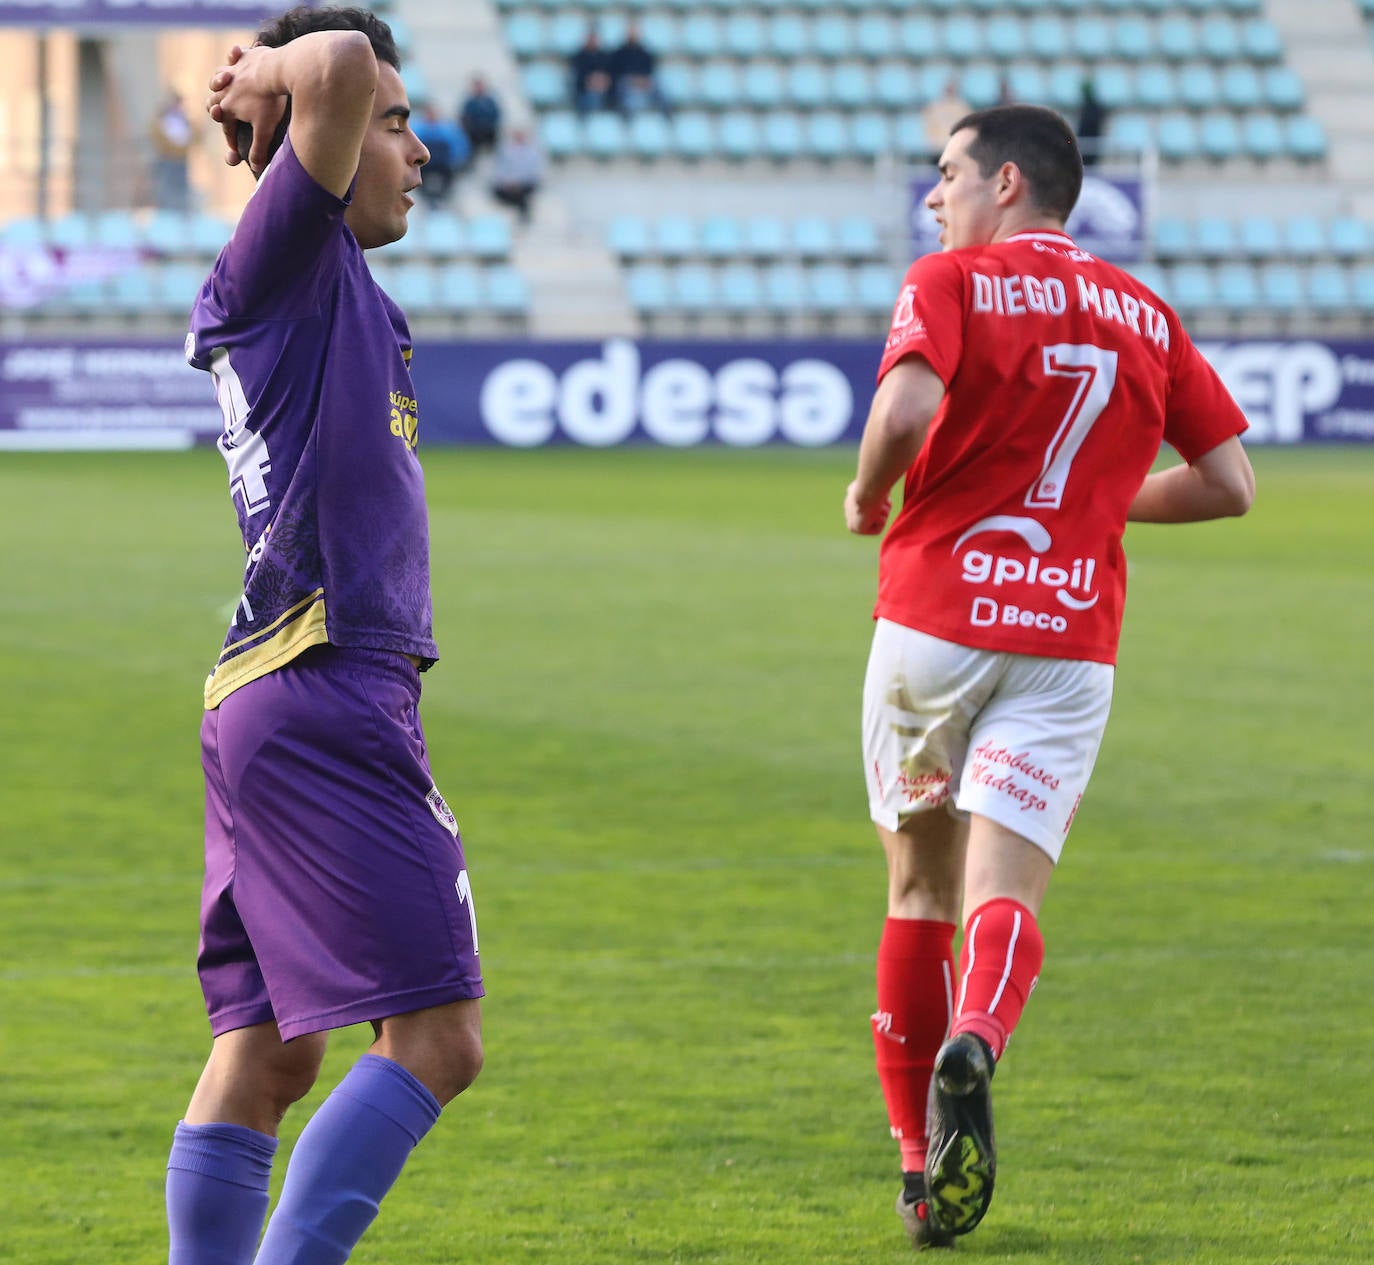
949,104,1083,221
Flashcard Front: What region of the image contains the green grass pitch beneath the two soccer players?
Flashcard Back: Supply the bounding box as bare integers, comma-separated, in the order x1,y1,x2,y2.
0,449,1374,1265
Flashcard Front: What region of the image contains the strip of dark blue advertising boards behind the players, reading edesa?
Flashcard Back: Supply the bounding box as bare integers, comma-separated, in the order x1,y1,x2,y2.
0,338,1374,449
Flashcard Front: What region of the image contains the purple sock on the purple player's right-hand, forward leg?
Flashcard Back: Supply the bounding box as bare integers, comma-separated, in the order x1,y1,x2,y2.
257,1055,440,1265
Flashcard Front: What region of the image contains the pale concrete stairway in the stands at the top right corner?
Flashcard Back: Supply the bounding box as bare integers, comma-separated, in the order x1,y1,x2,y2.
1264,0,1374,218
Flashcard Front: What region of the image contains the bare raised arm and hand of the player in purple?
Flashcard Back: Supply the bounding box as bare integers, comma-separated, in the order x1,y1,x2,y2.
206,30,378,196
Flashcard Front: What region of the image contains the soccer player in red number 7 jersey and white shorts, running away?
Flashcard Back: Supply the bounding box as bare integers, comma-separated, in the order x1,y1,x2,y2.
845,106,1254,1249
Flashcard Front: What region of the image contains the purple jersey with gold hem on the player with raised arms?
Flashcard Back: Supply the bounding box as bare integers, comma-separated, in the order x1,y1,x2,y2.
187,137,438,707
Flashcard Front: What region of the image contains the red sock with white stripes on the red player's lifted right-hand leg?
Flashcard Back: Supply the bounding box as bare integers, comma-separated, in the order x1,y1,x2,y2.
951,898,1044,1059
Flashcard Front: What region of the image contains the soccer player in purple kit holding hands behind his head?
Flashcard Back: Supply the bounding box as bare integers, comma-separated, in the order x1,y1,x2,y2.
166,8,482,1265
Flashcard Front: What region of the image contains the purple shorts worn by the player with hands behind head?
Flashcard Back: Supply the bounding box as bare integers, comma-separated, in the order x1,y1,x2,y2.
198,646,484,1041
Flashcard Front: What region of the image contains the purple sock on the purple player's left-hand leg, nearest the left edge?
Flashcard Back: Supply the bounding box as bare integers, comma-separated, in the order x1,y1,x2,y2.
168,1122,276,1265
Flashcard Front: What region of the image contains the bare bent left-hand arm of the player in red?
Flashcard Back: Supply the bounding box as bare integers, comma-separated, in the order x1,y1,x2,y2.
845,356,945,536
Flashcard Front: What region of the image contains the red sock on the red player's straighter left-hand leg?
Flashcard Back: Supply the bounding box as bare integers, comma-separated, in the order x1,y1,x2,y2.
872,918,955,1173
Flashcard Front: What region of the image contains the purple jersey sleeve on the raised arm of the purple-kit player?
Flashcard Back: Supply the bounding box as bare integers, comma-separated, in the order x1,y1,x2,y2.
210,133,352,319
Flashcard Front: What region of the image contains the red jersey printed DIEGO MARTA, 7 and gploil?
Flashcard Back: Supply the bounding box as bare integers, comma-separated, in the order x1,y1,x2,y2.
875,229,1246,663
